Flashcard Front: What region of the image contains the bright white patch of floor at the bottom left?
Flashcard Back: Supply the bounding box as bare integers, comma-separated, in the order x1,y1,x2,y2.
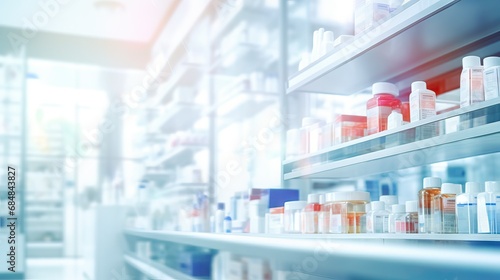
26,258,86,280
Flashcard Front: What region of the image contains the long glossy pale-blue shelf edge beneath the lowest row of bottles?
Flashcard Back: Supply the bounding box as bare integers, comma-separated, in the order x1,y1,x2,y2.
125,230,500,279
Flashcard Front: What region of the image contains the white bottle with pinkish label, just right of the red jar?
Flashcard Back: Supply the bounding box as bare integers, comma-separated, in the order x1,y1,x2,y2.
410,81,436,122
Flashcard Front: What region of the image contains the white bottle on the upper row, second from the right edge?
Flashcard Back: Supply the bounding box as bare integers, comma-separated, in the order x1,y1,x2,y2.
460,56,484,108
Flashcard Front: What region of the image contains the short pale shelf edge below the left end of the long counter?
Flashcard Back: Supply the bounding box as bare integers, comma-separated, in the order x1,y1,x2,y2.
124,254,204,280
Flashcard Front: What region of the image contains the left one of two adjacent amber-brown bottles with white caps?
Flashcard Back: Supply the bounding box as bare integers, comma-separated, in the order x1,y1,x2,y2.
418,177,441,233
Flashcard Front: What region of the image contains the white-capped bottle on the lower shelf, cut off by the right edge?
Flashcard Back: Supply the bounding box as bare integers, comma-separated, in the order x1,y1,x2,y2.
477,181,500,233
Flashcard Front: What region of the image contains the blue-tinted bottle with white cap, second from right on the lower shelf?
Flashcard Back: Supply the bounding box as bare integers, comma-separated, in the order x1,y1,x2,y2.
456,182,481,233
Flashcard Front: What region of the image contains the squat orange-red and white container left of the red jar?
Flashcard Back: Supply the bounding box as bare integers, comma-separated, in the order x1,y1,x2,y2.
333,115,366,144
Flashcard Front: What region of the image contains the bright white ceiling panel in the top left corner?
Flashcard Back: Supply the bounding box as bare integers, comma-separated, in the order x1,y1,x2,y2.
0,0,175,43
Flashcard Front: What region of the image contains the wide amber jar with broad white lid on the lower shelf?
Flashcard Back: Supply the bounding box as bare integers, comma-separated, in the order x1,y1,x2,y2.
325,191,370,233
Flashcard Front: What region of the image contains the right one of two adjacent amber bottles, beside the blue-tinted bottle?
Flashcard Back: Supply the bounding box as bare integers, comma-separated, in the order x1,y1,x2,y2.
432,183,462,233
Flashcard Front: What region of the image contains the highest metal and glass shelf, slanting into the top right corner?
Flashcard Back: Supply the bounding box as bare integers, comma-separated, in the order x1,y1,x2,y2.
287,0,500,95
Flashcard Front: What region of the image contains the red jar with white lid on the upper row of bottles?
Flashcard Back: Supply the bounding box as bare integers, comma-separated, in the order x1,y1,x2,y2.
366,83,401,135
